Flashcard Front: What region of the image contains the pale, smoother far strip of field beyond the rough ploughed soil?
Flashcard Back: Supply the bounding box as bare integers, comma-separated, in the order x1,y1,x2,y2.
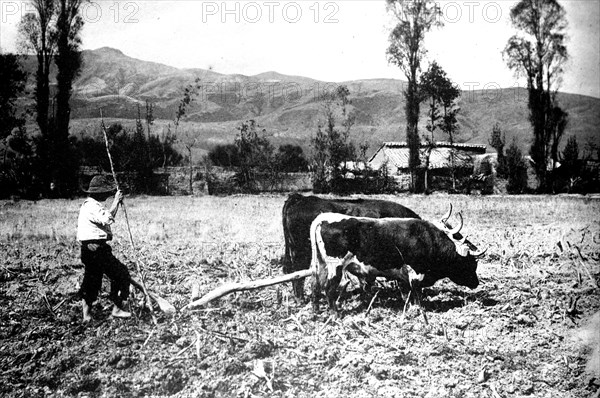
0,194,600,250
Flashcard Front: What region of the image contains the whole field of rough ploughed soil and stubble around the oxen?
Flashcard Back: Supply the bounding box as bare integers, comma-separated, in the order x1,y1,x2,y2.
0,195,600,398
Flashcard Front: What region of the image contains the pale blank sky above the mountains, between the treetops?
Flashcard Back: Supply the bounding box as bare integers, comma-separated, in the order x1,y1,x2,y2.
0,0,600,97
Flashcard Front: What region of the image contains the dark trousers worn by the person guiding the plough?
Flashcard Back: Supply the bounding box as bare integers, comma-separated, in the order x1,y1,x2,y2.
79,241,130,308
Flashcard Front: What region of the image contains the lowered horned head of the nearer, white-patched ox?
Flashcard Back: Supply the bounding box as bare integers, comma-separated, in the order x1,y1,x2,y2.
441,205,487,289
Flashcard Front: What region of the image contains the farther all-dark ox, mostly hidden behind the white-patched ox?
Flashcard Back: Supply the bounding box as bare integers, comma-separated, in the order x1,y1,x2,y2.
282,193,419,299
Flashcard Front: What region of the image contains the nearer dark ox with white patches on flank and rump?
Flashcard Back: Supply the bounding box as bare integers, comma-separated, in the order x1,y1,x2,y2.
310,213,482,312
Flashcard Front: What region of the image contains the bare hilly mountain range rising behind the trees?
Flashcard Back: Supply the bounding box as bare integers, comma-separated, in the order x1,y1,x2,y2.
17,47,600,161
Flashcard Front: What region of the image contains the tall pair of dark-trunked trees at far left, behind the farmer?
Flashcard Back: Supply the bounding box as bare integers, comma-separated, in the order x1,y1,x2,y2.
18,0,84,196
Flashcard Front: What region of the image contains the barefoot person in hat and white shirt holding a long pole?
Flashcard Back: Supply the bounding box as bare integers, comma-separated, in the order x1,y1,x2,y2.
77,175,131,322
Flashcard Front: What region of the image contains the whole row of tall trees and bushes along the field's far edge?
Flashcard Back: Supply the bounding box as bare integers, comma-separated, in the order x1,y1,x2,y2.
0,0,587,196
